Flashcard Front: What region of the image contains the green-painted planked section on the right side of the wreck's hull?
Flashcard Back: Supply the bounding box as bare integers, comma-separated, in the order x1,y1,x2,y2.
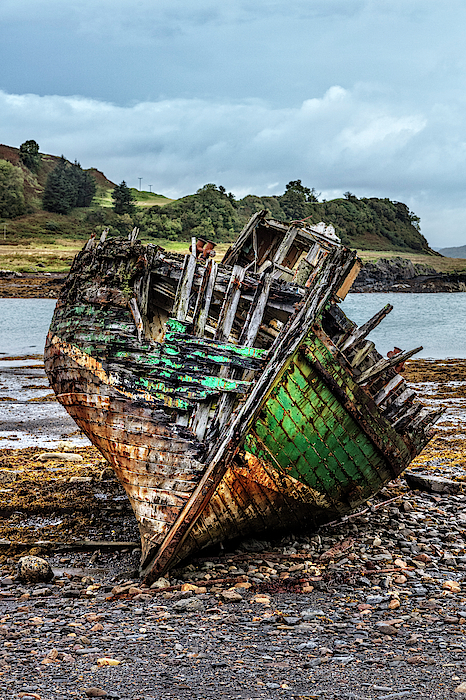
244,334,402,513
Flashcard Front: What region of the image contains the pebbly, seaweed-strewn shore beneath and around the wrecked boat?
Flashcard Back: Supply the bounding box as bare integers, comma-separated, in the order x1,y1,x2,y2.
0,360,466,700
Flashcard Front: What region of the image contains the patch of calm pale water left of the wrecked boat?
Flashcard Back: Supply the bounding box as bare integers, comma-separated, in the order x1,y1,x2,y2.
0,299,56,359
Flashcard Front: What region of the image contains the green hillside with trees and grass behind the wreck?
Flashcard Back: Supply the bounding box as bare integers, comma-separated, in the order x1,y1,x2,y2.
0,141,437,255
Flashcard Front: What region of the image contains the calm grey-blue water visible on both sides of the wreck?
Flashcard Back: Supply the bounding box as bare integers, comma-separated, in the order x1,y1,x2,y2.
0,293,466,359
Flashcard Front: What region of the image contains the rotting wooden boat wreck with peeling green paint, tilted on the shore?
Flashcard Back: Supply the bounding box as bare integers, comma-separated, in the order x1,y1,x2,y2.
45,212,439,583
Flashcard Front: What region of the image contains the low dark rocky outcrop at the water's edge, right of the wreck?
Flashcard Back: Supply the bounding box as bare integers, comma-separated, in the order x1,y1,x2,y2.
351,258,466,292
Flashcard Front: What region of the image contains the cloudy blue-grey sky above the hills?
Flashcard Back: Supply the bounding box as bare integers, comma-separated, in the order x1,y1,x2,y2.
0,0,466,247
